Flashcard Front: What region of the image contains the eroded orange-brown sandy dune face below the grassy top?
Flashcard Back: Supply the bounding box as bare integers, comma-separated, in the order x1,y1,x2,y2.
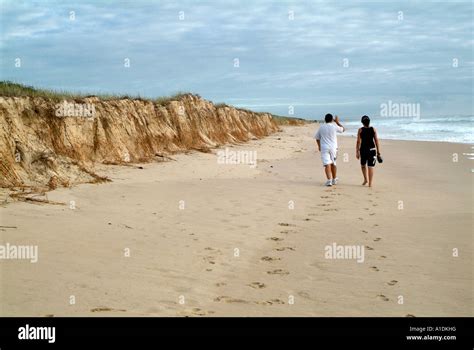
0,94,278,188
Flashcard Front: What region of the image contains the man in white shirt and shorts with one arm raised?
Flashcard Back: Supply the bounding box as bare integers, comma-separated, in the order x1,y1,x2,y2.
314,114,345,186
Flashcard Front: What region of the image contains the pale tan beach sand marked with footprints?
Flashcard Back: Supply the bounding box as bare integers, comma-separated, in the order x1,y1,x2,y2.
0,124,474,316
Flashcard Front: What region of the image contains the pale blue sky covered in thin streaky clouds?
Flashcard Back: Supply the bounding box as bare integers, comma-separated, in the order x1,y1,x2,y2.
0,0,474,119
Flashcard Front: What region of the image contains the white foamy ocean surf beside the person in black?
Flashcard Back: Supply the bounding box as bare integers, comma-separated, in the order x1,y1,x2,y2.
341,116,474,143
